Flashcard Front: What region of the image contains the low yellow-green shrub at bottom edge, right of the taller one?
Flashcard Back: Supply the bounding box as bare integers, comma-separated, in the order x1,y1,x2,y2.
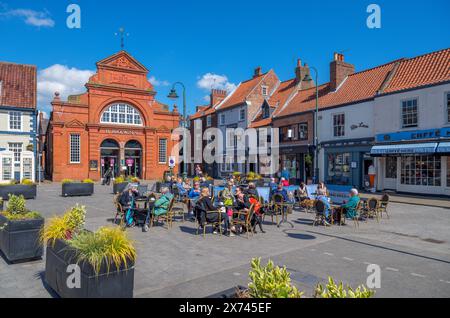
314,277,375,298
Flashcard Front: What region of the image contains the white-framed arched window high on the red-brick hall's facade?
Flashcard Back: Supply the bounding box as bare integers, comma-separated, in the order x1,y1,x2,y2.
100,103,142,126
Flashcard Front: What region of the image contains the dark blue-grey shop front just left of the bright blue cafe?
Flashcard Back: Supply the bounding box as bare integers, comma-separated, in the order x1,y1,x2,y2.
321,138,375,189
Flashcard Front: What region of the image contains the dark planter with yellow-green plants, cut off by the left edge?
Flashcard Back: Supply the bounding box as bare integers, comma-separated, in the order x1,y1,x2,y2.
0,195,44,262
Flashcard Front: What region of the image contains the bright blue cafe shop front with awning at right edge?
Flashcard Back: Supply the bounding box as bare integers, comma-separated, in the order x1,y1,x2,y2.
371,128,450,195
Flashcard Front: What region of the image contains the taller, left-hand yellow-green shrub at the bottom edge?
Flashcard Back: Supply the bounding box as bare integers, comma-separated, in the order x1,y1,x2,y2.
248,258,303,298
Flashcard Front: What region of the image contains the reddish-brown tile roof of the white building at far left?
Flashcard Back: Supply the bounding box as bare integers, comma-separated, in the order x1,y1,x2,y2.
0,62,36,108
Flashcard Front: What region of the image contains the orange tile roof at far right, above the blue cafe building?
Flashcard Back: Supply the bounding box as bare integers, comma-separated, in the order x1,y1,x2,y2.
383,48,450,93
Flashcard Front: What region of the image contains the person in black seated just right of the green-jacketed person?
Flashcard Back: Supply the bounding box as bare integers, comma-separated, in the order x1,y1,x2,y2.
194,188,230,234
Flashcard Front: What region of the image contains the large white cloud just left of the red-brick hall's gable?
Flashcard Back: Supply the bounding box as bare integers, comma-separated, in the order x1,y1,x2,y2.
37,64,95,110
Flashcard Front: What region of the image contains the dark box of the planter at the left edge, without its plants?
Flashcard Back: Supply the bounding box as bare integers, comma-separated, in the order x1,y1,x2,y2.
0,215,44,262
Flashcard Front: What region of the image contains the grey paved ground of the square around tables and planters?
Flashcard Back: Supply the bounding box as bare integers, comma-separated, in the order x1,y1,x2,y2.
0,183,450,297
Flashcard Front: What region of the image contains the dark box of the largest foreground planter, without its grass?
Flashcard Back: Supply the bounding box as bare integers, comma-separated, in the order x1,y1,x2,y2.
45,240,134,298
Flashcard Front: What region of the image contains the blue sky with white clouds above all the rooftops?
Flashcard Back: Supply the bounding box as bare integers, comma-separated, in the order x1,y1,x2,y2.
0,0,450,113
